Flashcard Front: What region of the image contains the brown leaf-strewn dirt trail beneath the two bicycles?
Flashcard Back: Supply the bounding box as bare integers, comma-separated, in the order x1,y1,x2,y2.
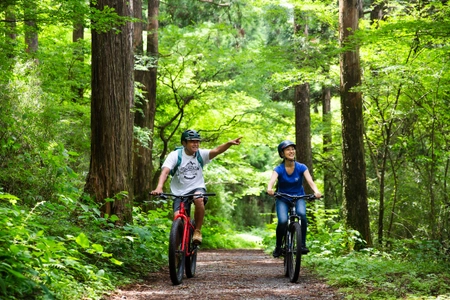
107,249,344,300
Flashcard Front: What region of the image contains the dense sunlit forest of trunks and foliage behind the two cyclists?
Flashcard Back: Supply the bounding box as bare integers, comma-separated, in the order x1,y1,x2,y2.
0,0,450,299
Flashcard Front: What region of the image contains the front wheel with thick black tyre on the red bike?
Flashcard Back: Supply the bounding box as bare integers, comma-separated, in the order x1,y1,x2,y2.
169,219,185,285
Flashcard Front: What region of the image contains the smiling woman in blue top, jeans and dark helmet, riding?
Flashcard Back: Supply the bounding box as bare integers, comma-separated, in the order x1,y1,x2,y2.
267,140,322,257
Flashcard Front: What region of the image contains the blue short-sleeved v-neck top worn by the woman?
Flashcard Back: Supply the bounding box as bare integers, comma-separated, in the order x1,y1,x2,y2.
274,162,308,196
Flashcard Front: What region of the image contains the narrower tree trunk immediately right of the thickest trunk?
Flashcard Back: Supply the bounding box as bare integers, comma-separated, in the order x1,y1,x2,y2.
133,0,159,202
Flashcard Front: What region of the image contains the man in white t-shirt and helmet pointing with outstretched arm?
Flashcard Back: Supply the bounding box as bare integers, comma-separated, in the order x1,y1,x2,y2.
151,130,242,244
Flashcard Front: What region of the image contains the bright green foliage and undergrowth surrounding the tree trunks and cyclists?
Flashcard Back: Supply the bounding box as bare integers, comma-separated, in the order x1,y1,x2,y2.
0,0,450,299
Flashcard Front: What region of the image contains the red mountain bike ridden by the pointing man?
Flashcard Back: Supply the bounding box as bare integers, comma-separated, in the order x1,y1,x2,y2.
159,193,216,285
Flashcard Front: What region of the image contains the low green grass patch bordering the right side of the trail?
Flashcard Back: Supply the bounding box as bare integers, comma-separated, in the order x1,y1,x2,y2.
303,244,450,299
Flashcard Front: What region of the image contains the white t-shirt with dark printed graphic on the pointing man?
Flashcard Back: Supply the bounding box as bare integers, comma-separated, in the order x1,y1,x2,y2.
162,149,211,195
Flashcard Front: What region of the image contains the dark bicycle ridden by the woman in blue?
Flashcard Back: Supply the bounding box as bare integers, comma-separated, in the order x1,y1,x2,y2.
274,193,317,282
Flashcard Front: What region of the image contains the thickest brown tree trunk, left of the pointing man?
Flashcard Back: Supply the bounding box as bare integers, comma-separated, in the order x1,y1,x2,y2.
85,0,134,224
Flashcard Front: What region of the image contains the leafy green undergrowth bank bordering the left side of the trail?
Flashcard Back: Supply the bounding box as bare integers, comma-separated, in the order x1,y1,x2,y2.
0,193,171,299
